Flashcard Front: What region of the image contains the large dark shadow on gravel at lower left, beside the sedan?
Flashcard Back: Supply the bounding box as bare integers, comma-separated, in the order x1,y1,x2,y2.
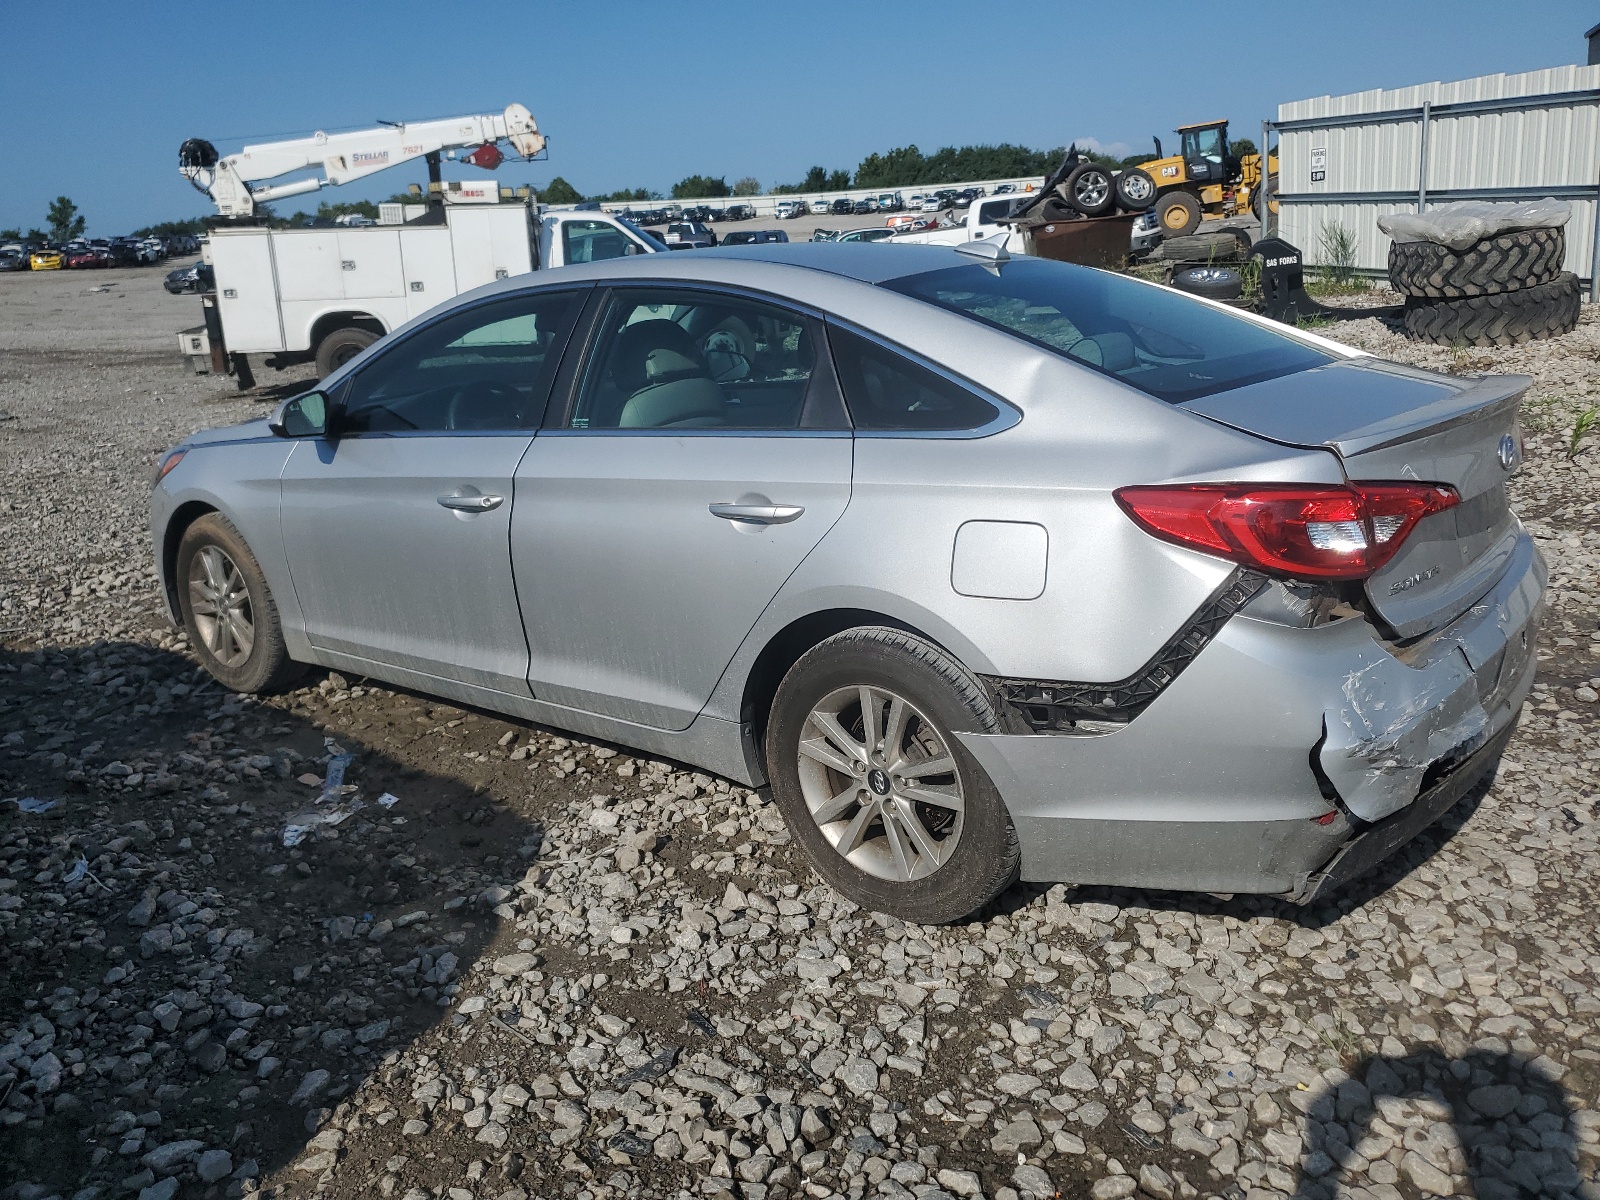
0,642,538,1197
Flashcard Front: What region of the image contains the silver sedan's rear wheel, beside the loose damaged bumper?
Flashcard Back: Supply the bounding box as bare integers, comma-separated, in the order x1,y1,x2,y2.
766,627,1019,925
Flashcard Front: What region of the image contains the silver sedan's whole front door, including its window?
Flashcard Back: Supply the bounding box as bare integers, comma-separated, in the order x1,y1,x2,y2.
282,291,584,696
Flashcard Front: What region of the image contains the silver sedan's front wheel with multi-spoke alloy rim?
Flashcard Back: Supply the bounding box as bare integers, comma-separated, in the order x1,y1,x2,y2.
178,512,306,693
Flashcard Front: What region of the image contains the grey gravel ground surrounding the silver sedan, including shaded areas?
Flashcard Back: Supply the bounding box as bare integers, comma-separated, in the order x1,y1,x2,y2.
0,270,1600,1200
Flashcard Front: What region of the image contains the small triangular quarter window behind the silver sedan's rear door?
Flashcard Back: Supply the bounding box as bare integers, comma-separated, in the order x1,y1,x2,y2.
827,325,1000,434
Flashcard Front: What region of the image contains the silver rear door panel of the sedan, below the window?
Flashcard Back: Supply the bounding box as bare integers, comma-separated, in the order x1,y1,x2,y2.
512,430,851,730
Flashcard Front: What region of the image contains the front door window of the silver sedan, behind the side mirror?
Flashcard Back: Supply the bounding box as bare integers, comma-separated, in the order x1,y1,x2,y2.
338,291,581,434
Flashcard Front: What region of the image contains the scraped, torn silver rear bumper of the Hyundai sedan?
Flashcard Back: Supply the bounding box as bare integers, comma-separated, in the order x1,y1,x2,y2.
958,534,1546,899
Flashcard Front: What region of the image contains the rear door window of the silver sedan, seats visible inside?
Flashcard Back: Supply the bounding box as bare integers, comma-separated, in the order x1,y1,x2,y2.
568,288,821,430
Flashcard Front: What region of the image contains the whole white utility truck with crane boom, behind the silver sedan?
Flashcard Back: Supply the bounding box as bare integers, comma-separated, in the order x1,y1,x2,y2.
178,104,666,389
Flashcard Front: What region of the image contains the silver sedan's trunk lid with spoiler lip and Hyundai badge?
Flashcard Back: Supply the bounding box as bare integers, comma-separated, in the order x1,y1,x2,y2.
1184,358,1533,637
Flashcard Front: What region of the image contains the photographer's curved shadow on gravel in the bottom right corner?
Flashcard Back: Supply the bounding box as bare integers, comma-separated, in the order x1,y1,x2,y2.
1294,1050,1581,1200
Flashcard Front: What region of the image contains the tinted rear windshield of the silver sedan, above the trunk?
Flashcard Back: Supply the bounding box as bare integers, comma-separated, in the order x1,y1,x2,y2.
883,259,1333,405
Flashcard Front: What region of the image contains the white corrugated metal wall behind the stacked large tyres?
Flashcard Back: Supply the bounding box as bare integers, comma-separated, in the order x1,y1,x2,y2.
1277,66,1600,289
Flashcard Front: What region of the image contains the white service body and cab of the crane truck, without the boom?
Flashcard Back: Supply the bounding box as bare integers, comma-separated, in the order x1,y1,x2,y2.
178,200,666,389
